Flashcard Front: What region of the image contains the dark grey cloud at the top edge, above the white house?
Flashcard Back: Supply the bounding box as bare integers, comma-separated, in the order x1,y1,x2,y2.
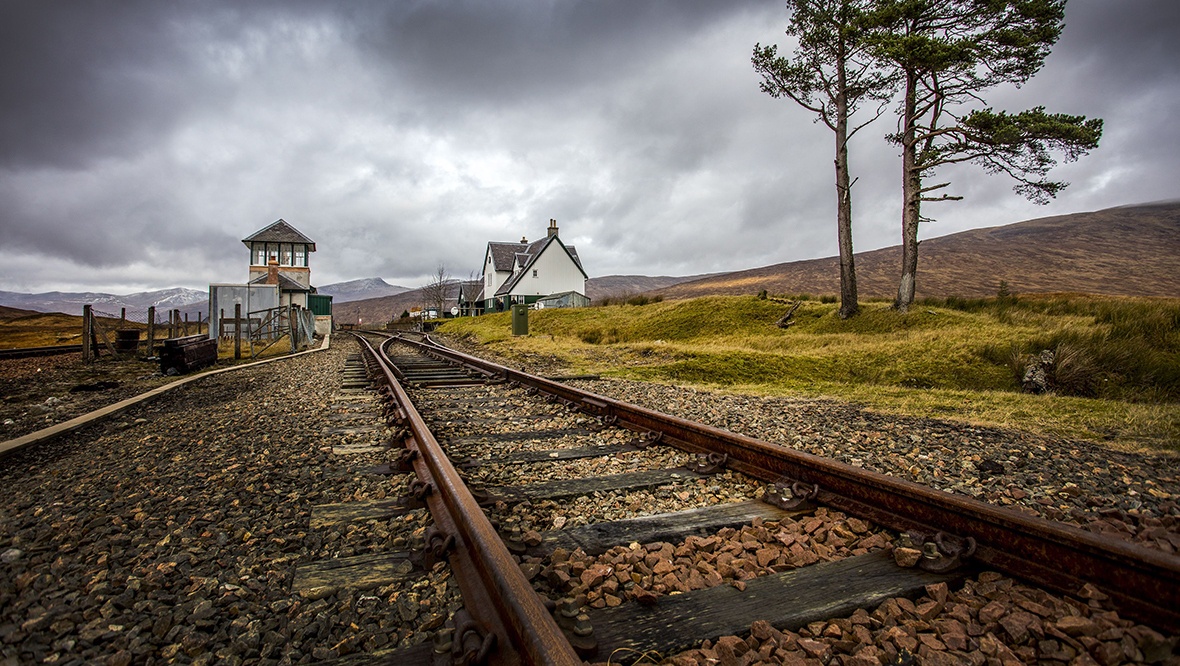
362,0,753,106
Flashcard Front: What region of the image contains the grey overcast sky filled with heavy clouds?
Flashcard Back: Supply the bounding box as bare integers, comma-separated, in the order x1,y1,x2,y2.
0,0,1180,293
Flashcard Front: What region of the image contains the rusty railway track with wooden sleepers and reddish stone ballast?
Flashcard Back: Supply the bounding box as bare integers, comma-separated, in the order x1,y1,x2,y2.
353,339,1180,664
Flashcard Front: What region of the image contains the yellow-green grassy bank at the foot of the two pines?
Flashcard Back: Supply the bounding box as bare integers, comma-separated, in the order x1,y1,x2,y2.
440,296,1180,450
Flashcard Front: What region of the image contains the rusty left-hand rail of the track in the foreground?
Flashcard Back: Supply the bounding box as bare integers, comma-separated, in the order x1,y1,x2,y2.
346,335,582,666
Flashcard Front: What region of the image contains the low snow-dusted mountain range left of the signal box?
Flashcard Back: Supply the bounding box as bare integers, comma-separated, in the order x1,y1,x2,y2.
0,287,209,319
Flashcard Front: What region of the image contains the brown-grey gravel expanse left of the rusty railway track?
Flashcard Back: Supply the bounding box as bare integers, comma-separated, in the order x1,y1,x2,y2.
0,338,458,666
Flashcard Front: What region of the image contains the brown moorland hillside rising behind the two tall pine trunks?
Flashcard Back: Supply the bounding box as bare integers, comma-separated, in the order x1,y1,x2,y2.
655,202,1180,299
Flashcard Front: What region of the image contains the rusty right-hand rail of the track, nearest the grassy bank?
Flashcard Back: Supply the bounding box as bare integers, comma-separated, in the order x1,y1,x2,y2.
401,338,1180,632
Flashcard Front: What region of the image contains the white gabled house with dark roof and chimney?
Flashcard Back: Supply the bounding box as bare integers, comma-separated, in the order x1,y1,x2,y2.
474,220,588,312
